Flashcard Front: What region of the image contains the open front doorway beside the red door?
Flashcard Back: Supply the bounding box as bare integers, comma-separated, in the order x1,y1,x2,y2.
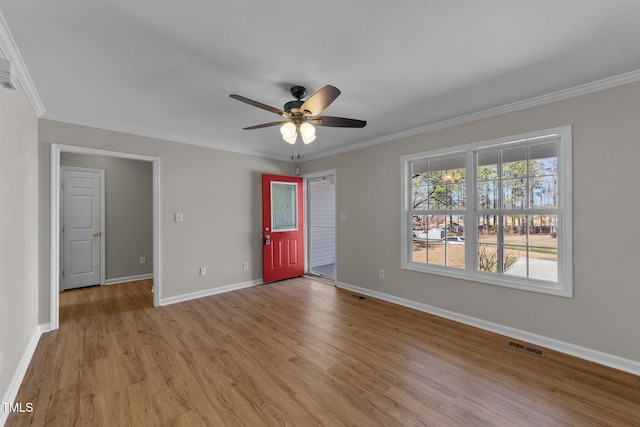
306,171,336,281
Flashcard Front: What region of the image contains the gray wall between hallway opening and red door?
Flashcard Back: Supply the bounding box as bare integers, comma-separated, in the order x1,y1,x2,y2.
38,119,295,323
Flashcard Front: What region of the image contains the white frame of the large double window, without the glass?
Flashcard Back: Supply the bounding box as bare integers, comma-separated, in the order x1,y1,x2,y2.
401,126,573,298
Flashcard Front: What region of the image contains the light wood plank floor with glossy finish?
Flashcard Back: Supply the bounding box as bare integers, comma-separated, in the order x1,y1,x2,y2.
7,278,640,426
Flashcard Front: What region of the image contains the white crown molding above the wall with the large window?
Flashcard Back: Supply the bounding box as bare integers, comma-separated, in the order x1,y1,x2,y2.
305,70,640,161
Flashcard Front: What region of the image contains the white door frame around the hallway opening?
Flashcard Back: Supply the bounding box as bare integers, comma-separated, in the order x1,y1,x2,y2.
49,143,162,330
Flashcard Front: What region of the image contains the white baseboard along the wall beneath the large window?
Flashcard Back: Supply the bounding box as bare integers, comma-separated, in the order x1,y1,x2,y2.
336,282,640,375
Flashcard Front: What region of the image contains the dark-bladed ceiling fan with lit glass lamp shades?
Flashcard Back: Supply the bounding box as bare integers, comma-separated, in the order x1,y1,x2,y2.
229,85,367,144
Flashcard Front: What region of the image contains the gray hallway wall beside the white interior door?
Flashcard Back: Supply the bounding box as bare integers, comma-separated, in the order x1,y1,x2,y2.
60,153,153,280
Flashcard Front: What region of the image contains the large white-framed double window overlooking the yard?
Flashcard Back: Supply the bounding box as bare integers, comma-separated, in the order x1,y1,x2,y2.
402,126,573,297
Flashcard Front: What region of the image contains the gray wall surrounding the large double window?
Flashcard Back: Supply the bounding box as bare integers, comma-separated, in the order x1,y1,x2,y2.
301,83,640,361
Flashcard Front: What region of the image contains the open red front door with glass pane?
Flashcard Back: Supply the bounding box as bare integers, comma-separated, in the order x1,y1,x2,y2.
262,175,304,283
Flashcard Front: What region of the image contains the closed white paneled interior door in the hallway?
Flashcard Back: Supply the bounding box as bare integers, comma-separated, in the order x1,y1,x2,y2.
62,168,104,290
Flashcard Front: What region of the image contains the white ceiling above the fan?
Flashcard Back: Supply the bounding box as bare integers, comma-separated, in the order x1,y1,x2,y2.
0,0,640,159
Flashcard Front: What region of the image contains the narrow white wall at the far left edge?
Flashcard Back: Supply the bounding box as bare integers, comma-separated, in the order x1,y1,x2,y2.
0,53,39,416
